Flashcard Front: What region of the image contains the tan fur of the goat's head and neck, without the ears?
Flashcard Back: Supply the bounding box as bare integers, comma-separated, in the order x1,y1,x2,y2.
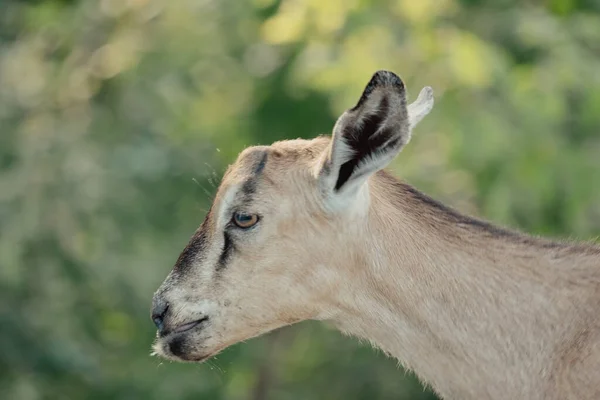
155,72,600,400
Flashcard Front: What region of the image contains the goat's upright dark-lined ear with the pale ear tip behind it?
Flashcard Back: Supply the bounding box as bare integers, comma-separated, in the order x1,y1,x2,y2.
319,71,433,203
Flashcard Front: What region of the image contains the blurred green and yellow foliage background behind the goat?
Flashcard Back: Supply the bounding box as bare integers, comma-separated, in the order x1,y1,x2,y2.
0,0,600,400
